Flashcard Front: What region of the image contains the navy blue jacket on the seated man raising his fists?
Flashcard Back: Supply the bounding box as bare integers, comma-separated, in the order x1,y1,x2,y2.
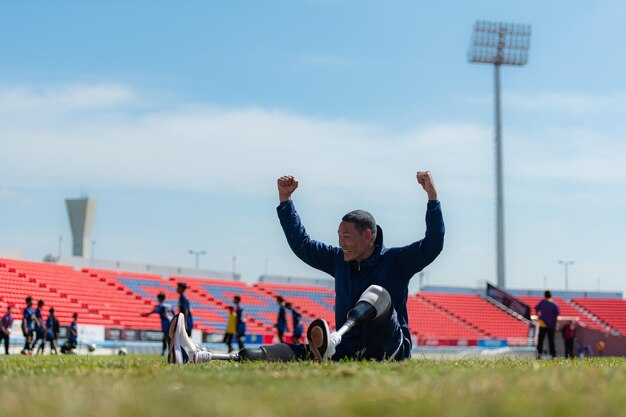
277,200,445,359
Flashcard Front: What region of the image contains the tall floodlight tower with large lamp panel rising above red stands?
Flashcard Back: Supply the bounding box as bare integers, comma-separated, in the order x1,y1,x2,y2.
469,20,530,288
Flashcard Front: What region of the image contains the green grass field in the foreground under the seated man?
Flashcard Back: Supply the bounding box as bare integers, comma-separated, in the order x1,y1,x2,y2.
0,355,626,417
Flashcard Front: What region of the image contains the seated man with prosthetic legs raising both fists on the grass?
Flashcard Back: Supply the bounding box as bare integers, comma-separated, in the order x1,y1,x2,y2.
170,171,445,363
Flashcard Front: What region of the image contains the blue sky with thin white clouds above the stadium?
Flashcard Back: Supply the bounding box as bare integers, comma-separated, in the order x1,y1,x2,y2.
0,0,626,291
